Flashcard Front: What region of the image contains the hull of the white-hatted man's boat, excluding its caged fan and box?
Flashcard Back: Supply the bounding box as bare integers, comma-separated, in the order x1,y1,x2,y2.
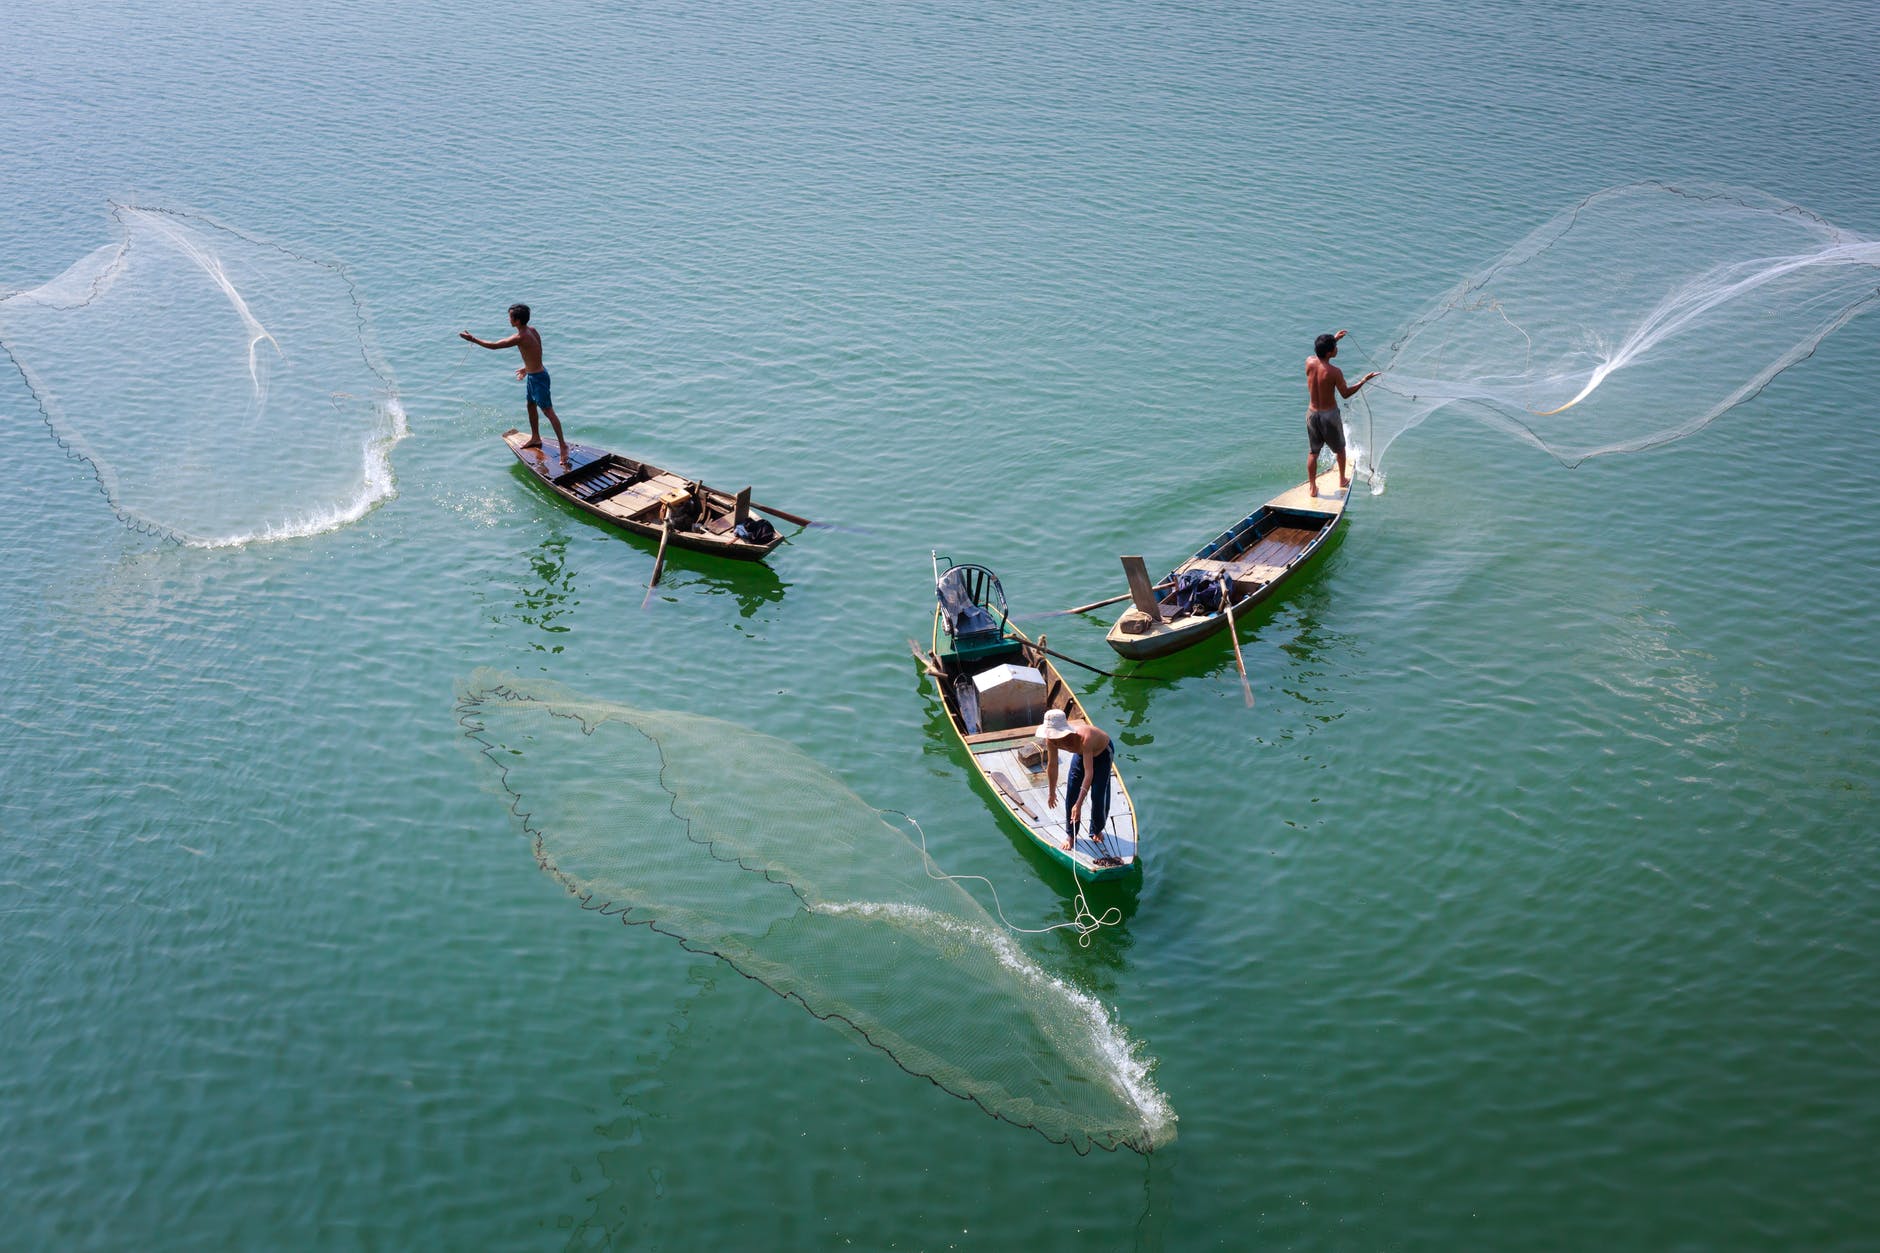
925,564,1141,880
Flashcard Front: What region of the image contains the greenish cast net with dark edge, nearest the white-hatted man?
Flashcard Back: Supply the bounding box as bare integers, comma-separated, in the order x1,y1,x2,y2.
457,670,1175,1153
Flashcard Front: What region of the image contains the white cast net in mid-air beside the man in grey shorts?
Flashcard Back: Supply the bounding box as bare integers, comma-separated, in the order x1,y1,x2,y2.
1346,182,1880,489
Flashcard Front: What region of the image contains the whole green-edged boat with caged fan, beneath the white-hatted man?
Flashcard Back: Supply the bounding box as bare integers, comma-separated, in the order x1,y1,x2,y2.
916,557,1141,879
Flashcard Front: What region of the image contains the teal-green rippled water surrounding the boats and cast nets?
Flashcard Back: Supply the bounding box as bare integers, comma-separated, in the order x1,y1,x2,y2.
0,0,1880,1249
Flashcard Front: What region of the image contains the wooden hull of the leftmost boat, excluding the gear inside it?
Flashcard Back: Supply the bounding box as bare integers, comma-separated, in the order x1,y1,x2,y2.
502,431,784,561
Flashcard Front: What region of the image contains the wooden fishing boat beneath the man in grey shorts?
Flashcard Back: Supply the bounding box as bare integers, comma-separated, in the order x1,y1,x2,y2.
1104,468,1352,660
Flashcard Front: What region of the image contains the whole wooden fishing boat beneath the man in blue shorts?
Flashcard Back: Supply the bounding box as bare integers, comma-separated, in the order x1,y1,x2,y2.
502,431,803,561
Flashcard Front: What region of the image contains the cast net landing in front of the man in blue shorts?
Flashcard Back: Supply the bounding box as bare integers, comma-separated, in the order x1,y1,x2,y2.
0,205,404,546
